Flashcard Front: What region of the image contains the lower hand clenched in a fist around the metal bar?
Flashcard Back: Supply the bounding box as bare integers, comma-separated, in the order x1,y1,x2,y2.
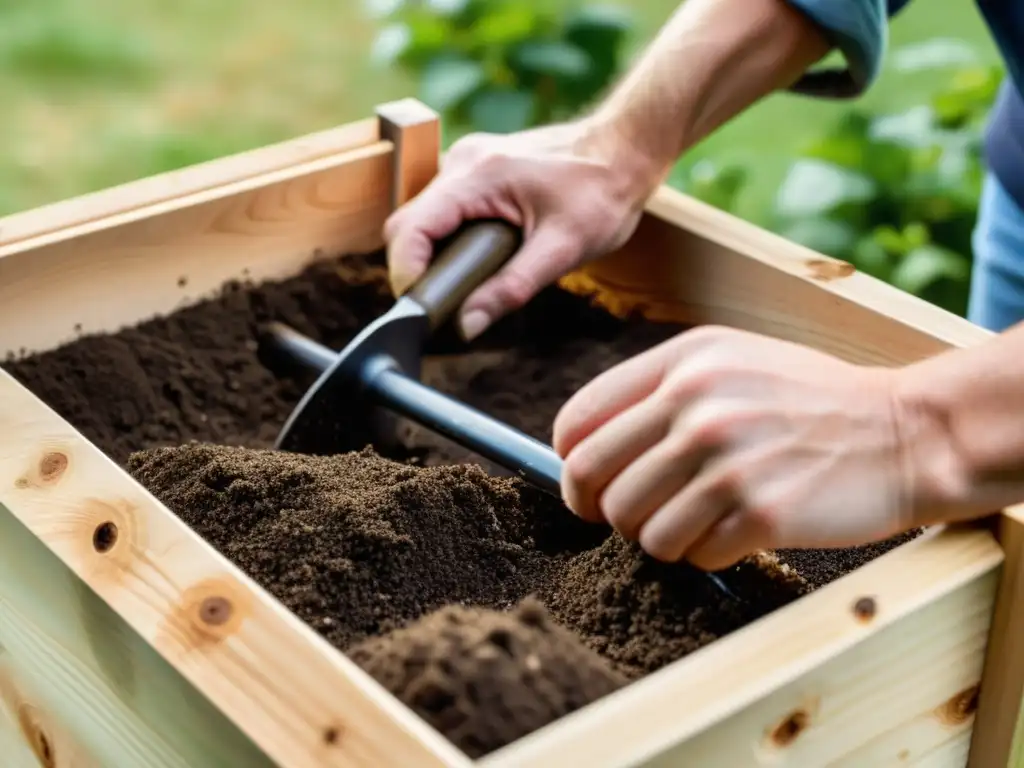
554,328,914,570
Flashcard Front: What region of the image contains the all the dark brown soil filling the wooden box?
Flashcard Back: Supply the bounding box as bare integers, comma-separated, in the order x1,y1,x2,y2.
5,254,921,756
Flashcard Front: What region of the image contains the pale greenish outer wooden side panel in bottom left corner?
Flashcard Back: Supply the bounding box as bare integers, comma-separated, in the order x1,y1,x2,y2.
0,508,272,768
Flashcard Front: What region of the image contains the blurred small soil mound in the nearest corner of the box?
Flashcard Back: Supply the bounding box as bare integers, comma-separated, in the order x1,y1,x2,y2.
348,599,627,758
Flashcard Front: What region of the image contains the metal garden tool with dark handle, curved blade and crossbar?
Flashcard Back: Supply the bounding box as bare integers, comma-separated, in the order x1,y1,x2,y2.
268,220,735,598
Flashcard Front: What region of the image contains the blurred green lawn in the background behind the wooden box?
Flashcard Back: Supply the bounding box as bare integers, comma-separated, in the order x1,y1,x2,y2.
0,0,995,219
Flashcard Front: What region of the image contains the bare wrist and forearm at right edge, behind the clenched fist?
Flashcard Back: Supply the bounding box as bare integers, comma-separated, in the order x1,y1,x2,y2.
899,324,1024,522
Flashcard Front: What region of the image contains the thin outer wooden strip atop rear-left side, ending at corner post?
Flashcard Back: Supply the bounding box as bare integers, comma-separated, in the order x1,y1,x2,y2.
0,118,380,249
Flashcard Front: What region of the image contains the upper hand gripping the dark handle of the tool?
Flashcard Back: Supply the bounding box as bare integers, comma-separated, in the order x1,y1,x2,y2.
384,116,657,340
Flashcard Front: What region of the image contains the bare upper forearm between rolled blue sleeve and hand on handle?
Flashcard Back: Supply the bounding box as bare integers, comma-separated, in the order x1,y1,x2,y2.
594,0,829,193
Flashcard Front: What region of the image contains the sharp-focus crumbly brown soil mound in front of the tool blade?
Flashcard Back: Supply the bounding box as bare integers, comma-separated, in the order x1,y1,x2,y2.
128,443,586,649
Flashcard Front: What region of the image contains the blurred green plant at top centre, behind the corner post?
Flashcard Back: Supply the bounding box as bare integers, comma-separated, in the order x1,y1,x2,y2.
375,0,632,133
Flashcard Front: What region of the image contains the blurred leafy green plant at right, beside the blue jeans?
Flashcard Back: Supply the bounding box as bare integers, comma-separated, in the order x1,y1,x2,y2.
671,54,1004,315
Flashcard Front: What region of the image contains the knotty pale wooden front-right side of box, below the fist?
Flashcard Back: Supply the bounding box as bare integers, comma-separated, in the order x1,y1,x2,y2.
480,527,1002,768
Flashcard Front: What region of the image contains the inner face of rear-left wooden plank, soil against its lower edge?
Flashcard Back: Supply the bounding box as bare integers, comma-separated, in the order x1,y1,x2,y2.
0,141,393,359
